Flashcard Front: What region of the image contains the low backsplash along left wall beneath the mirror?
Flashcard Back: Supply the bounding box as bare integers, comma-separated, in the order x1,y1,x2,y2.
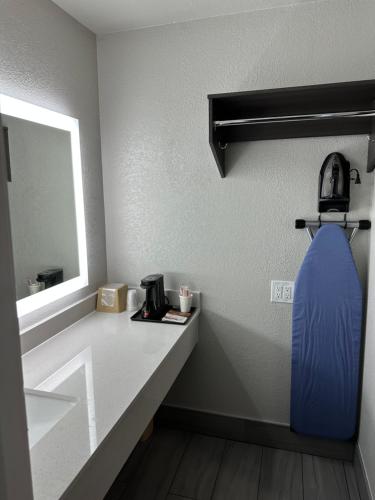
20,292,97,354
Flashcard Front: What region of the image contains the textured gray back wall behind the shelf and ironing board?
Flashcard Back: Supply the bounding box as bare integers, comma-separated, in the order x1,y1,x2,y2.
98,0,375,423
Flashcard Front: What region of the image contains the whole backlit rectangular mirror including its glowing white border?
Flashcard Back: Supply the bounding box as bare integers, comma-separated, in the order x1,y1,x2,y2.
0,96,88,316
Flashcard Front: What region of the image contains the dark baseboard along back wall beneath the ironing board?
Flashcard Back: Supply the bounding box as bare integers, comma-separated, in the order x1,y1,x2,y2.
155,405,355,462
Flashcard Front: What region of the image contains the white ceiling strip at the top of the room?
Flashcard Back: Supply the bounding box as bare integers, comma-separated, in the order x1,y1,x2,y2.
53,0,319,34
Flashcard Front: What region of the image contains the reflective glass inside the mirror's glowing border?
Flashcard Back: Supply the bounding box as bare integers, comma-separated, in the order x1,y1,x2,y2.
2,115,79,300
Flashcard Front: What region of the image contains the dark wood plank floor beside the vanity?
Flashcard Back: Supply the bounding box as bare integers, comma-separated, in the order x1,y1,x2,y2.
105,428,361,500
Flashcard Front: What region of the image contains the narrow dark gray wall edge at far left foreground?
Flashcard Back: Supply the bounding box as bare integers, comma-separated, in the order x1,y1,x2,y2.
0,113,33,500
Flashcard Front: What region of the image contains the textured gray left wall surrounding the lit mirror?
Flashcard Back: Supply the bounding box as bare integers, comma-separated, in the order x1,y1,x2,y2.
0,0,106,326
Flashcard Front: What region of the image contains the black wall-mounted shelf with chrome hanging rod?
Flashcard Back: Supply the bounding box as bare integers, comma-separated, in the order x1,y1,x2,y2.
208,80,375,177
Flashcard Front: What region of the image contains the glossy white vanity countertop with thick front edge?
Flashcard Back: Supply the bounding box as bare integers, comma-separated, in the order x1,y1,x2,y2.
23,311,199,500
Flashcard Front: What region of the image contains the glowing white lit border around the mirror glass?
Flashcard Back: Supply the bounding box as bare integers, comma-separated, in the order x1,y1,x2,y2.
0,94,88,318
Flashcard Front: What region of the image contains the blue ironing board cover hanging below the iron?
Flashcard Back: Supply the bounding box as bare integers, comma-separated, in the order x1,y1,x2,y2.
290,224,362,440
